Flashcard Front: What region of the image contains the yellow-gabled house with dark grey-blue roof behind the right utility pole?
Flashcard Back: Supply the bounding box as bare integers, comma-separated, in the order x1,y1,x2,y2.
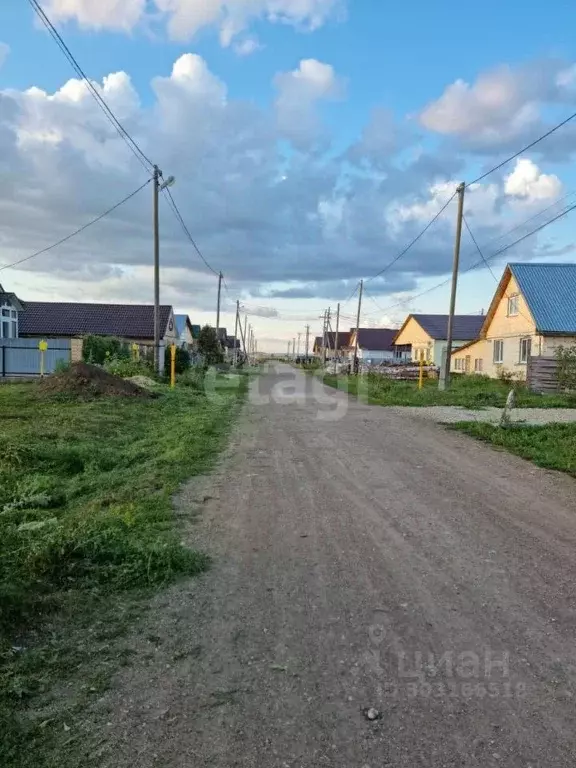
394,315,484,367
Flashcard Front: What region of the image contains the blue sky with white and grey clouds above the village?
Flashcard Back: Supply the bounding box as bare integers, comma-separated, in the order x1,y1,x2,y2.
0,0,576,351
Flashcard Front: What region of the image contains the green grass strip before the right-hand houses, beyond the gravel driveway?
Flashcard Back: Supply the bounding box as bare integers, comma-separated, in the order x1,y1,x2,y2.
324,374,576,408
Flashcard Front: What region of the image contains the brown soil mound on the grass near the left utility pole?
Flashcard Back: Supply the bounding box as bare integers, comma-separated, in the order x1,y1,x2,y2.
38,363,153,399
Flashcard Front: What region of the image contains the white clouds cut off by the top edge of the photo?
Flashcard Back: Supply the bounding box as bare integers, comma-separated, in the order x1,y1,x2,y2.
46,0,345,46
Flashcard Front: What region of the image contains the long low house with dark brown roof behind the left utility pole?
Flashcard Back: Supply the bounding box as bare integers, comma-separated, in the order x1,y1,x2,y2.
18,301,178,361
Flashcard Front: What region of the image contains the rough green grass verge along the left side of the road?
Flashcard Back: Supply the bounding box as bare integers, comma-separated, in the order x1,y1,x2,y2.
0,376,248,768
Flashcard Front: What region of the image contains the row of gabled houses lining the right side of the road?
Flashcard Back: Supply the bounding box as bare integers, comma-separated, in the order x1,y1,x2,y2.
314,263,576,378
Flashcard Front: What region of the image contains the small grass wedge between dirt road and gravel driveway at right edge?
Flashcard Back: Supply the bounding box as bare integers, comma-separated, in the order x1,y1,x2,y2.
450,422,576,477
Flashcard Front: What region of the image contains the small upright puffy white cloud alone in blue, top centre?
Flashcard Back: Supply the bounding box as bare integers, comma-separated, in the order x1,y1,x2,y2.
274,59,344,148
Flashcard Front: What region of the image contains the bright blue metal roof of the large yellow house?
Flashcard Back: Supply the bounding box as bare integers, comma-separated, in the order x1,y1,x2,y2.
508,264,576,335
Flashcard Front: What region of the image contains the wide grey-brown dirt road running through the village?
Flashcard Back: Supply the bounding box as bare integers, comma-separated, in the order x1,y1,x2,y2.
96,366,576,768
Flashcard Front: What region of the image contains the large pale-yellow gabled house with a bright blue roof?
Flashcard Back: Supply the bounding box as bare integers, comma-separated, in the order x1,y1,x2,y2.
451,264,576,379
